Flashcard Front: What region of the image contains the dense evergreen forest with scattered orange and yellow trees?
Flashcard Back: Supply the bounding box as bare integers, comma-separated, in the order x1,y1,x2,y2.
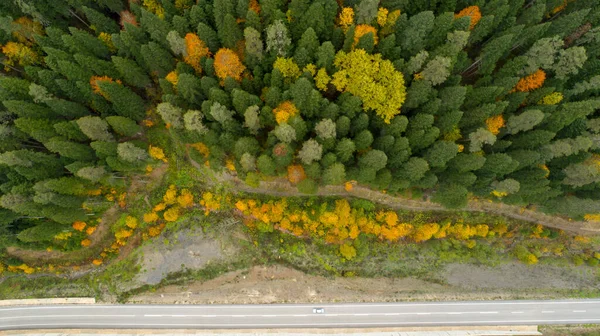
0,0,600,249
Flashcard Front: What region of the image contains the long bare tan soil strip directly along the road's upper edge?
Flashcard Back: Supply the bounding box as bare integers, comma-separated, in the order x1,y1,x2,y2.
129,264,599,304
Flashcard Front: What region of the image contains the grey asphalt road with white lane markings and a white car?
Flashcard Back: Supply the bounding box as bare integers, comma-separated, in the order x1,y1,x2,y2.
0,299,600,330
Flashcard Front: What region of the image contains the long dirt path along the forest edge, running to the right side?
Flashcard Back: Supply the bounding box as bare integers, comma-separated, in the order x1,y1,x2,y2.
190,158,600,235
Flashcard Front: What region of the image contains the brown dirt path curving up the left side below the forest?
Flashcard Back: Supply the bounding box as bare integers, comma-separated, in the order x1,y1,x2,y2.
6,164,169,266
